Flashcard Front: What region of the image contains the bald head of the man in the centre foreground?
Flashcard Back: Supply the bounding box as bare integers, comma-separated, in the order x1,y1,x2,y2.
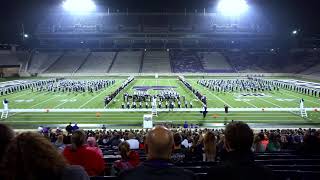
145,126,173,160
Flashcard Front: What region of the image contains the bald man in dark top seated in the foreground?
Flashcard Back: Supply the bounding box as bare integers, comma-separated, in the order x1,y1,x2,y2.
120,126,195,180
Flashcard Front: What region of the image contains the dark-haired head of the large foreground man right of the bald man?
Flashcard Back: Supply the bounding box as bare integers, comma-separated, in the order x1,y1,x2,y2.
225,122,253,152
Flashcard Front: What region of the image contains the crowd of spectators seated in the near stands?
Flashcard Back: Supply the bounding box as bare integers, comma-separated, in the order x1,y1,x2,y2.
0,122,320,179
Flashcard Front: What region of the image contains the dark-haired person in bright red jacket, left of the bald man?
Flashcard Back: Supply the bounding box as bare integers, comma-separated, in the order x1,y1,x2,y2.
63,130,105,176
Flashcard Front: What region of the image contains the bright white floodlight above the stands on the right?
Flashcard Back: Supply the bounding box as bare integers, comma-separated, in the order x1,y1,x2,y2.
218,0,249,16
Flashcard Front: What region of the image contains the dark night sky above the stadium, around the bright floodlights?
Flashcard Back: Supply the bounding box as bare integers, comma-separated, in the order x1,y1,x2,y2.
0,0,320,43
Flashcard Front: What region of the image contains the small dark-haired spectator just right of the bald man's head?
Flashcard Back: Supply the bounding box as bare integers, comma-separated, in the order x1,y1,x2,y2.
171,133,187,163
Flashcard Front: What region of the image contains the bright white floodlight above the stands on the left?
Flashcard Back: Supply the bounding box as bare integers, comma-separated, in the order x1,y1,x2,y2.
62,0,96,13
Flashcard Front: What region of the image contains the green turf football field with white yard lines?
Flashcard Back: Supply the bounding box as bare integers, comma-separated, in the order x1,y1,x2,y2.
1,77,320,128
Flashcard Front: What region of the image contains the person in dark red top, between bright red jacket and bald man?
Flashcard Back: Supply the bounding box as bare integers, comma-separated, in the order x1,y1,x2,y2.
111,141,140,175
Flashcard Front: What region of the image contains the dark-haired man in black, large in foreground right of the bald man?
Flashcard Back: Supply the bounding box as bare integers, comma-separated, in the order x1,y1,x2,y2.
207,122,272,180
